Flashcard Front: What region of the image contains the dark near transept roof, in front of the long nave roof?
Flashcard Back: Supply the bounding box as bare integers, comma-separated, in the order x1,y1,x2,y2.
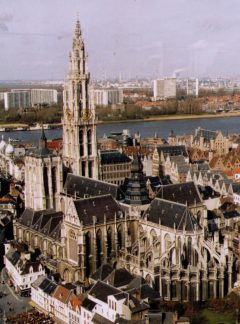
74,195,123,226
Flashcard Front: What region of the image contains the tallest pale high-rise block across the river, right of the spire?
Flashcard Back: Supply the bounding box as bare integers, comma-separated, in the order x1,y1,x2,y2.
153,78,176,100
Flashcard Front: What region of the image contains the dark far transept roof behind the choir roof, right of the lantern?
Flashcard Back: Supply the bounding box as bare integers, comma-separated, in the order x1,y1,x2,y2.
156,181,202,206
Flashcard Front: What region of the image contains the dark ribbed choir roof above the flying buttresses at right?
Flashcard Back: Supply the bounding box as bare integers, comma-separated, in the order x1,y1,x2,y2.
146,198,201,231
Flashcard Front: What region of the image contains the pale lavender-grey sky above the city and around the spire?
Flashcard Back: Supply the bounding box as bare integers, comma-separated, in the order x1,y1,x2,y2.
0,0,240,80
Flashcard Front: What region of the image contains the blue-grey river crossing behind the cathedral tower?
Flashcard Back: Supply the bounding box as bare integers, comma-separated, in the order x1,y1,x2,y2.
0,117,240,143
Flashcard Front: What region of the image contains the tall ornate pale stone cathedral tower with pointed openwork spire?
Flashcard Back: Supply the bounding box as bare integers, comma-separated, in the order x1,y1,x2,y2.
62,21,98,179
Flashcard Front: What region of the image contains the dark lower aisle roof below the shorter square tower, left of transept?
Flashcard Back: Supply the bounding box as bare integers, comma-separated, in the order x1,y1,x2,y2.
17,208,63,240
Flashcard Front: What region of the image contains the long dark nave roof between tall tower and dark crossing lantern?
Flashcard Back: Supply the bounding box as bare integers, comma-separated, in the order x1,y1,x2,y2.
63,173,124,200
